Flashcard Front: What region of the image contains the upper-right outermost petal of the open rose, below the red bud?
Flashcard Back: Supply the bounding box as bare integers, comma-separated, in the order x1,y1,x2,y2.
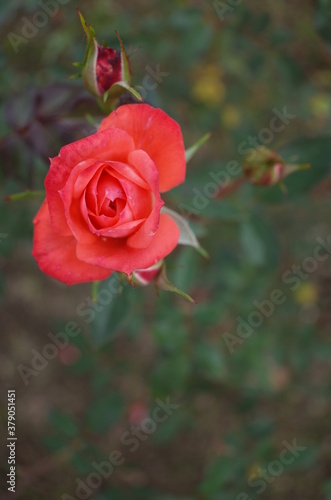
99,104,186,193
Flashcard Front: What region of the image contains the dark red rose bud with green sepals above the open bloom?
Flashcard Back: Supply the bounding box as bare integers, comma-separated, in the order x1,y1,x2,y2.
74,9,142,102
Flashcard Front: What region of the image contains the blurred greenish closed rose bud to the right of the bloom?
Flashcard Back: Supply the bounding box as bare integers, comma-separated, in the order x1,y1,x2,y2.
243,146,310,186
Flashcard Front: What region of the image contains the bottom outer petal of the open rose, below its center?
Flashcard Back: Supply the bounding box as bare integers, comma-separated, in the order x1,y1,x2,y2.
77,213,180,274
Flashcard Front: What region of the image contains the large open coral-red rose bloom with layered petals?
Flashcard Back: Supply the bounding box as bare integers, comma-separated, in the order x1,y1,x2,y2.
33,104,186,284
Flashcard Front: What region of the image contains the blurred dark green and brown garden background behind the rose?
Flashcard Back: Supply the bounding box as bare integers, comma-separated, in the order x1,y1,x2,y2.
0,0,331,500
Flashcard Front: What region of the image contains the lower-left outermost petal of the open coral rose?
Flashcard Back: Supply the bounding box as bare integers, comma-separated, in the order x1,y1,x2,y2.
32,200,112,285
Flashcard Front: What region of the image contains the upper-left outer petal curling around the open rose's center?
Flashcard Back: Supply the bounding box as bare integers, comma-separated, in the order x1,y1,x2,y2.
45,128,134,236
